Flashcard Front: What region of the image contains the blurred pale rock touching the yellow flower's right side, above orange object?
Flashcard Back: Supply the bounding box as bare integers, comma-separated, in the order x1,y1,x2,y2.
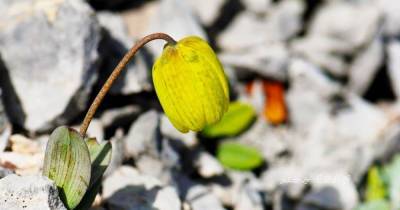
219,43,289,81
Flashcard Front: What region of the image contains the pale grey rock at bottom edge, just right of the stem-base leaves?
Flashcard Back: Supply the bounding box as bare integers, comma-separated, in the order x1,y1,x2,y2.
103,166,181,210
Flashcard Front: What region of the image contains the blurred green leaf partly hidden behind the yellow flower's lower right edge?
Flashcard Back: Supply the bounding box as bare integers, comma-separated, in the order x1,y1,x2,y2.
201,102,256,138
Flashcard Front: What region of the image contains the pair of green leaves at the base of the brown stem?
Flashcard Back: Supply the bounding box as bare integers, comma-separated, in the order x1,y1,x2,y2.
43,126,111,209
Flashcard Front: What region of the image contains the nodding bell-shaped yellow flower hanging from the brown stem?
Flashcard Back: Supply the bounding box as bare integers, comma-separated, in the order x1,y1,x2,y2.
153,36,229,133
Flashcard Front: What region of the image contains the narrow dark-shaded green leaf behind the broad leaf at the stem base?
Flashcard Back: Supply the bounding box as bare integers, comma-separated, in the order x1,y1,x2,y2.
76,138,112,210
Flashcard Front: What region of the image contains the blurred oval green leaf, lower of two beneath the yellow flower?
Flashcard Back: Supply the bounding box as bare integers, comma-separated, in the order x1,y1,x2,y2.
217,142,263,170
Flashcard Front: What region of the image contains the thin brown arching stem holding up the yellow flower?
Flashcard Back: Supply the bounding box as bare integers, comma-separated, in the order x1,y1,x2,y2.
79,33,176,136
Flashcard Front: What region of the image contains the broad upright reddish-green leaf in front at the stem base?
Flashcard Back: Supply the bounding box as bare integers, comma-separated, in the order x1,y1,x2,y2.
43,126,91,209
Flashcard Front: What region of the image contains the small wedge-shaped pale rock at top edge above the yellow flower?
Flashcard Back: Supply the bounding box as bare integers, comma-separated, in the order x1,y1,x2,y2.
188,0,227,26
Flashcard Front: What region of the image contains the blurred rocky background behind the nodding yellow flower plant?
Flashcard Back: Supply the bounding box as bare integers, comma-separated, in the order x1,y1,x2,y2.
0,0,400,210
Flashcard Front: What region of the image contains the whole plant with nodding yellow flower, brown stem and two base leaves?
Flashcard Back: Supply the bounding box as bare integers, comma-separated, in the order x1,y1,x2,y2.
43,33,229,209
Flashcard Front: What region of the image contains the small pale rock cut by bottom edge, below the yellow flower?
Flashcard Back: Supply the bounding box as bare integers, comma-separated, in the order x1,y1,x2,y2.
185,185,225,210
